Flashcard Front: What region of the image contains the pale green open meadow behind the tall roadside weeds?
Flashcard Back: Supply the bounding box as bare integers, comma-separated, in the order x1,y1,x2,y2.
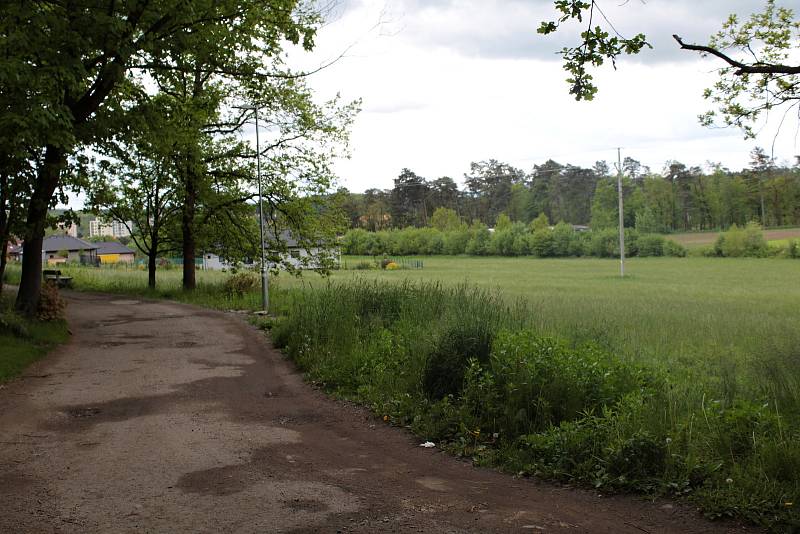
9,256,800,388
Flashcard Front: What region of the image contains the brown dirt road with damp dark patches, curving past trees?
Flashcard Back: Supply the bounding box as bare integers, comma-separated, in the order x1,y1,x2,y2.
0,294,756,534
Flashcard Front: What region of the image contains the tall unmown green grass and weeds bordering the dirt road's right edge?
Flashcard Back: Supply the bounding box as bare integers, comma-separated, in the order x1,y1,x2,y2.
272,279,800,528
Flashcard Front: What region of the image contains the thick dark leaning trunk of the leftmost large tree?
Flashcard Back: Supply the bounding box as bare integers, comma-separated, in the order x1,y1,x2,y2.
16,145,67,317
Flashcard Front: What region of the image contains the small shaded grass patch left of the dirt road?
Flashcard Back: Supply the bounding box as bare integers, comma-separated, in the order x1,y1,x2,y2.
0,293,69,383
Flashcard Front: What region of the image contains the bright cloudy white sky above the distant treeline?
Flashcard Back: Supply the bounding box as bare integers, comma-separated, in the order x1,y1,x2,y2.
282,0,800,192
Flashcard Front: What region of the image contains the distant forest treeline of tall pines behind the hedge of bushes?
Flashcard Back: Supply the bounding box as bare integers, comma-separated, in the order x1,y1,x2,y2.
340,148,800,233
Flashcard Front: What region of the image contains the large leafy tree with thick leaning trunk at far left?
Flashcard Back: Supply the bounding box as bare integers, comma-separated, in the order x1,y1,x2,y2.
0,0,316,314
